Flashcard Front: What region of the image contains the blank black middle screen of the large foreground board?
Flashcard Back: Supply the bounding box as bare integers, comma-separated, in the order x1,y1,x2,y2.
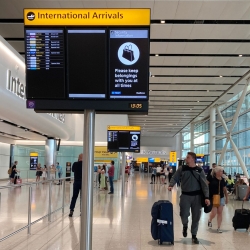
67,29,107,99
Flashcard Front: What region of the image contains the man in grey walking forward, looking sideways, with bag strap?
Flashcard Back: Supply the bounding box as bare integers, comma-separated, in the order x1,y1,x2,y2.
168,152,210,244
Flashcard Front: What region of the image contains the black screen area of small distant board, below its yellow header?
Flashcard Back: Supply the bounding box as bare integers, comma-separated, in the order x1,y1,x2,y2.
108,130,141,153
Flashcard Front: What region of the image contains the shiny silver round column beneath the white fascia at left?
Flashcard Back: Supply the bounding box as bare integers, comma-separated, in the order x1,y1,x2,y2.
45,138,56,179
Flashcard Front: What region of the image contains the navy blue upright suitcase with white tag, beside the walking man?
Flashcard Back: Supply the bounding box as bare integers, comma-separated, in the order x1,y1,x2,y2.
151,200,174,245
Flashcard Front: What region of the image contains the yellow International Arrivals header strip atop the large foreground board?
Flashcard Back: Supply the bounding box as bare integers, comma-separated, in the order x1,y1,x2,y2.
24,9,150,26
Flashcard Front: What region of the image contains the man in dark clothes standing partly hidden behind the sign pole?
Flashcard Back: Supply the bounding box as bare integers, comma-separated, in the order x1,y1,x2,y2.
69,154,83,217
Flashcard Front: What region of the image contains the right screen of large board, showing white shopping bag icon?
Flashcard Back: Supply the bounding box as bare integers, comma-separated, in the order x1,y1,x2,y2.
109,29,149,100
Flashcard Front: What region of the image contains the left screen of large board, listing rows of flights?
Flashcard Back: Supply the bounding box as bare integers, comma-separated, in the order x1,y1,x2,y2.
25,28,65,99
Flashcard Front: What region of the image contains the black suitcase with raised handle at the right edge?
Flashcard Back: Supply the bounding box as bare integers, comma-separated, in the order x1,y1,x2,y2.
233,201,250,230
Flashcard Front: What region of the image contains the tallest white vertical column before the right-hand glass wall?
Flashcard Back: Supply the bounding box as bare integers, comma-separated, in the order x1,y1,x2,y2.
209,107,216,166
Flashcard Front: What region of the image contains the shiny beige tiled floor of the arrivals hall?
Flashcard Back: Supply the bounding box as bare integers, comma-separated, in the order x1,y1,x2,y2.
0,172,250,250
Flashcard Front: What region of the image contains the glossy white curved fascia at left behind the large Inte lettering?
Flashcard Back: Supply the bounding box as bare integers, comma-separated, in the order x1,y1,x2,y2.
0,36,74,140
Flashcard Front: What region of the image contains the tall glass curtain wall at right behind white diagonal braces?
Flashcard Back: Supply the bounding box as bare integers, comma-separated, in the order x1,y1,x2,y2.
182,90,250,174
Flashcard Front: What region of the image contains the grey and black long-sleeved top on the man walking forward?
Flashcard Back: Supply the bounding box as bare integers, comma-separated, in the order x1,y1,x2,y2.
169,166,209,199
